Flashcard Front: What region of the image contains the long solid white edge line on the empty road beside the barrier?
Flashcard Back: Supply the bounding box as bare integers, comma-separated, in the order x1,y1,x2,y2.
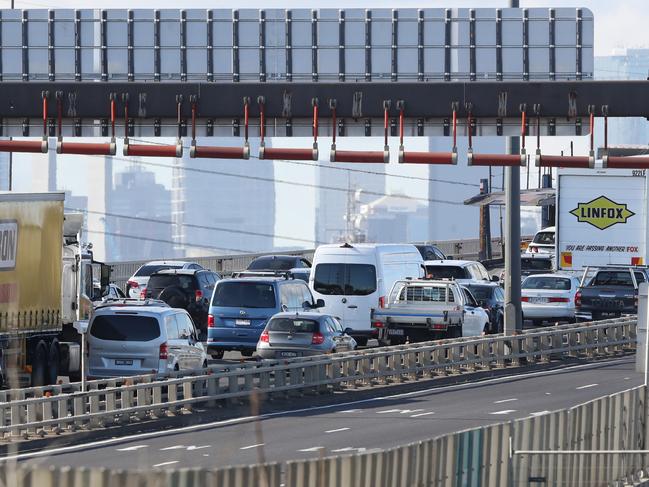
0,357,633,462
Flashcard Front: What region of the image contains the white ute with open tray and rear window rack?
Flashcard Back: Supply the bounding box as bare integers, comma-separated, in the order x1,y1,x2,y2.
372,279,489,345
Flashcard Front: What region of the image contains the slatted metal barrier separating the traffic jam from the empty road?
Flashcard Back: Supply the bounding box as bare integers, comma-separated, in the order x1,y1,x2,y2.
0,317,637,439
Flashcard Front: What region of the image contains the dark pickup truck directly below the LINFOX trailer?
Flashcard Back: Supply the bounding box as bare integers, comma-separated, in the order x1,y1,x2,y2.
575,266,648,321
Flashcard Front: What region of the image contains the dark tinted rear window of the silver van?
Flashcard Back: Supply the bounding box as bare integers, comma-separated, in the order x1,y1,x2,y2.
90,314,160,342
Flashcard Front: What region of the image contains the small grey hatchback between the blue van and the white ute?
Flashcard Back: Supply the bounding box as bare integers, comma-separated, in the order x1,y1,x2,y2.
257,313,356,359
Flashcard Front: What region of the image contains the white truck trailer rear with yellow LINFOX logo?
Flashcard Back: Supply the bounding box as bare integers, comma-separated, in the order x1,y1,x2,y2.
556,169,649,274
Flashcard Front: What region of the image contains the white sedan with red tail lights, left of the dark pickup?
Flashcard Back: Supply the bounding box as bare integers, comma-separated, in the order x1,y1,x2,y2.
521,274,580,325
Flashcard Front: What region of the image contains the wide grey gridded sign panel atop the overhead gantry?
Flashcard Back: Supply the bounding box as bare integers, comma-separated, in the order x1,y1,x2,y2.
0,8,593,135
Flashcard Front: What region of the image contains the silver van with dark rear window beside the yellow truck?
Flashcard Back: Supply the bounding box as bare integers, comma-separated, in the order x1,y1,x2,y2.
87,300,207,378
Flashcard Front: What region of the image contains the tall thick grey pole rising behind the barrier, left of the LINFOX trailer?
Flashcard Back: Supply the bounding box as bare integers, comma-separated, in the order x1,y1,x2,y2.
504,0,523,335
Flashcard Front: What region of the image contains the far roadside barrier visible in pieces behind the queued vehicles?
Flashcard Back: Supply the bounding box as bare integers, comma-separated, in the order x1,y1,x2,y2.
110,237,512,289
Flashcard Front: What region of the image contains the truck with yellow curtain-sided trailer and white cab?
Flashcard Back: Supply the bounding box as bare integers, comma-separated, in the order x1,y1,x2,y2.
0,193,110,387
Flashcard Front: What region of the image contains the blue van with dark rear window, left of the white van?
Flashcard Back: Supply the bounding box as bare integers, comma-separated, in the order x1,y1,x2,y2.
207,277,324,359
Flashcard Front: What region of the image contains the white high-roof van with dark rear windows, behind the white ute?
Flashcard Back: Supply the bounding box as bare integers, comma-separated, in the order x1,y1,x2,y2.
309,244,424,346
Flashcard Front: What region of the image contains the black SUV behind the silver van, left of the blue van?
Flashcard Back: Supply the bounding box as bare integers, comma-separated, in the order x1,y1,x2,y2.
144,269,221,336
